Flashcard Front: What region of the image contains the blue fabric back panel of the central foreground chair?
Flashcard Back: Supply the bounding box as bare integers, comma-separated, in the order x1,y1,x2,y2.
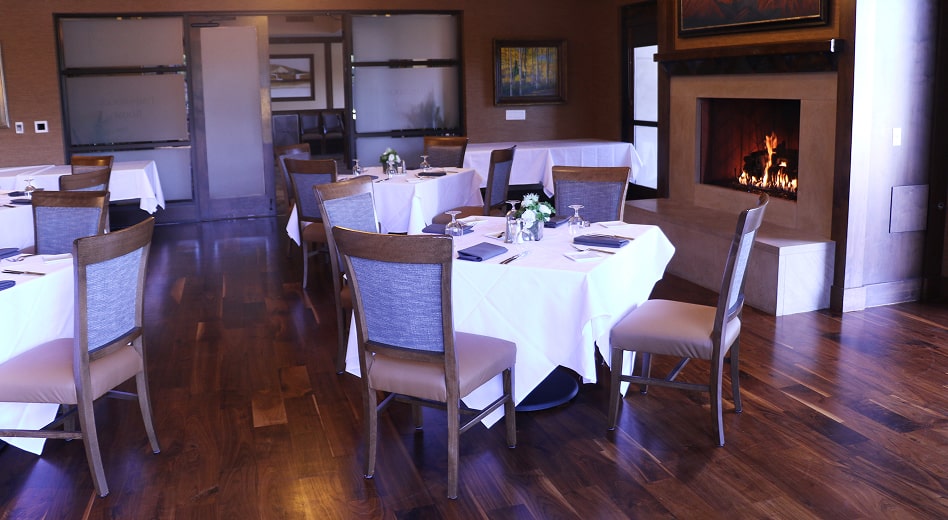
349,257,444,352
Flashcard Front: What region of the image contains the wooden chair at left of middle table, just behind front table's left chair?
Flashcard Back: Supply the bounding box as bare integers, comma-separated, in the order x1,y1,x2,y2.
283,156,338,289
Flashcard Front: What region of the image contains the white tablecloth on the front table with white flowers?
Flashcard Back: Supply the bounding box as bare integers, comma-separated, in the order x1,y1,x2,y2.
346,217,675,426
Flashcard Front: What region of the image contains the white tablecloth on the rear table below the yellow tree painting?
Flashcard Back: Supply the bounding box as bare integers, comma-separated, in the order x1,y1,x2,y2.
464,139,644,197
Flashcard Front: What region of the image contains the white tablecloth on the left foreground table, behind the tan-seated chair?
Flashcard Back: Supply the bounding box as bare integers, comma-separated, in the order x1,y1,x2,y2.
0,256,74,454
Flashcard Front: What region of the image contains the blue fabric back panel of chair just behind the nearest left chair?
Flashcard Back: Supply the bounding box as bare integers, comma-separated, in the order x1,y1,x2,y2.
33,206,102,255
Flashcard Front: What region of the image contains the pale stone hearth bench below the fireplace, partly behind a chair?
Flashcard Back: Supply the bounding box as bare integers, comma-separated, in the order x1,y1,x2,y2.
625,199,835,316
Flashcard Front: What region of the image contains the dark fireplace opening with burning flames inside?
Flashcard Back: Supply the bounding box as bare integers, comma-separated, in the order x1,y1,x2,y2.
699,98,800,200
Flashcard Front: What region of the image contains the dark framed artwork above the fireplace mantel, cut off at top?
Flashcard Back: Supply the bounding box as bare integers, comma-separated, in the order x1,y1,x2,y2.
678,0,829,36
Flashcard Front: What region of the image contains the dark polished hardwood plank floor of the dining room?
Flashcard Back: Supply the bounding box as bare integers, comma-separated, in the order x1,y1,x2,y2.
0,219,948,520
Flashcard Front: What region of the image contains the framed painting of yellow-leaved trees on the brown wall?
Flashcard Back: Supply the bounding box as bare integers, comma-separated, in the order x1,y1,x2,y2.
494,40,566,105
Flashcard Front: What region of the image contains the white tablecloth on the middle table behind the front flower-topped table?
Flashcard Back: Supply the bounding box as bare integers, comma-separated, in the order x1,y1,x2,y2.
286,167,484,240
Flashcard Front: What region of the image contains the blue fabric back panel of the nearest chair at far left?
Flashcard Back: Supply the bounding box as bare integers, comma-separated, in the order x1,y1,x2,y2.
86,247,145,352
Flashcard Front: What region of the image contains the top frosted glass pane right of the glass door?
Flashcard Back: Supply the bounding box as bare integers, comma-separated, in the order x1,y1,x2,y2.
352,14,458,62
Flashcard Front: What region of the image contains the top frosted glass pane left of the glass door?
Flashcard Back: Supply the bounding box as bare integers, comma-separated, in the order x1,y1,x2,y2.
60,17,184,68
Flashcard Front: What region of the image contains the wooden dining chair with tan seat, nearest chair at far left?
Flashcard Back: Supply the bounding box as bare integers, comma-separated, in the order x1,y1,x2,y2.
0,217,160,497
